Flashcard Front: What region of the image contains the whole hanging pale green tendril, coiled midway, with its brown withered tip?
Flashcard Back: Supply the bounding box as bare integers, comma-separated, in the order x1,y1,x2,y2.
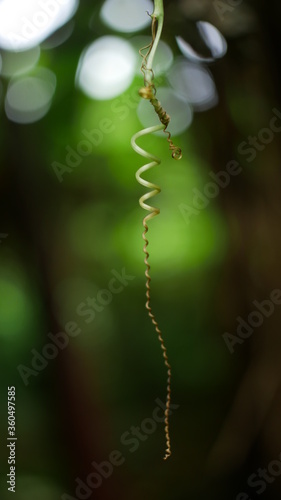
131,0,182,460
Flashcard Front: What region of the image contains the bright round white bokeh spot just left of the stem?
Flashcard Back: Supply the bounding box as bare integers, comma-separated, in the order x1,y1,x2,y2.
76,36,136,100
